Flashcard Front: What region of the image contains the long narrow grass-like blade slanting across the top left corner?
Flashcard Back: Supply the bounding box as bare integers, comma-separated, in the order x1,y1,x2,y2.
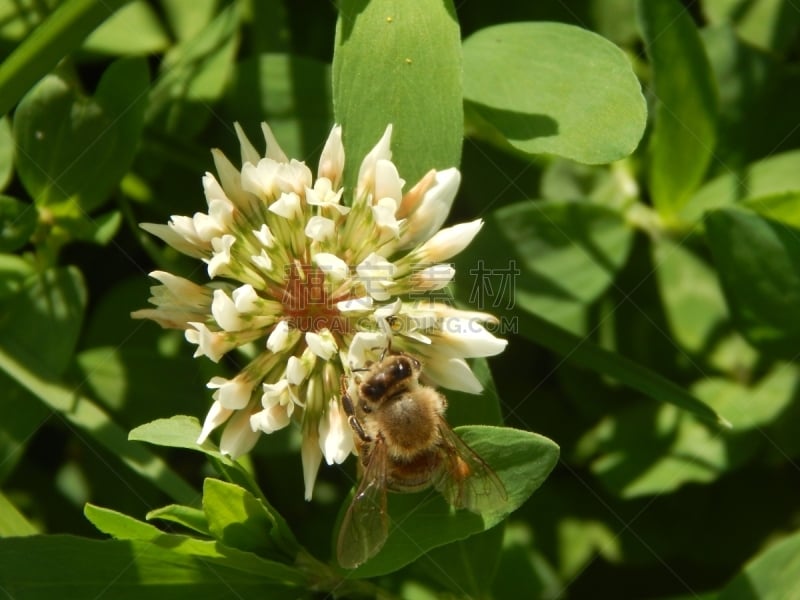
0,0,129,117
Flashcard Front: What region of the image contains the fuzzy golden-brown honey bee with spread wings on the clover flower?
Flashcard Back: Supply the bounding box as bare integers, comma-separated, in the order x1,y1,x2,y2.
337,353,507,569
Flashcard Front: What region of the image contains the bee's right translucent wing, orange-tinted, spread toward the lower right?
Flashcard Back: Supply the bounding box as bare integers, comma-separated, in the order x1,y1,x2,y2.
436,419,508,514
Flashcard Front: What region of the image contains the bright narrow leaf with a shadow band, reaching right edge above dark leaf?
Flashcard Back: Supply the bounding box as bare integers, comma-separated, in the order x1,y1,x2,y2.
681,150,800,221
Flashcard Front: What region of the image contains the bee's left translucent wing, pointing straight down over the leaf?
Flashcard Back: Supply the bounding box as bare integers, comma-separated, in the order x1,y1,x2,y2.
336,438,389,569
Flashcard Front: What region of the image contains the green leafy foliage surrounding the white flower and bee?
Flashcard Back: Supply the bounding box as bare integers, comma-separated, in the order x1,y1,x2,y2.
0,0,800,600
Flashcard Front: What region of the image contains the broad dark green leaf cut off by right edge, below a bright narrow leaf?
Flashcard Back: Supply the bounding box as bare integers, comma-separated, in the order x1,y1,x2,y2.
706,209,800,360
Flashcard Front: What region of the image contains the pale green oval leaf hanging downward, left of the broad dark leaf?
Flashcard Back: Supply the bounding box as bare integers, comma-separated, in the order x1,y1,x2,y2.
653,238,728,356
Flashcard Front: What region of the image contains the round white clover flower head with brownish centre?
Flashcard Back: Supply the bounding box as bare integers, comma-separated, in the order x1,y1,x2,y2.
132,124,506,499
